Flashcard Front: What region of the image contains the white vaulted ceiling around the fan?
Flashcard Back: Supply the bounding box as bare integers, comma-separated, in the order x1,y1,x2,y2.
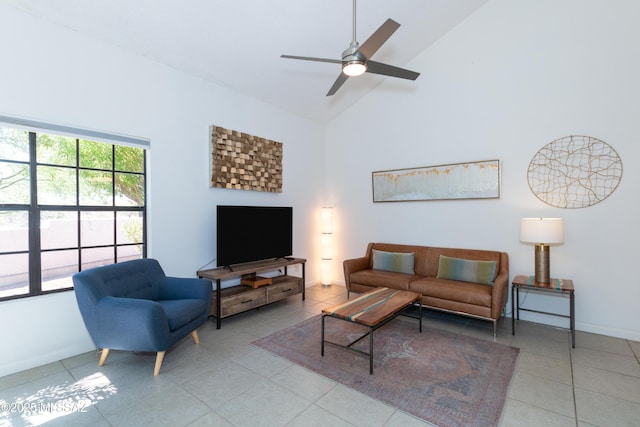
0,0,487,123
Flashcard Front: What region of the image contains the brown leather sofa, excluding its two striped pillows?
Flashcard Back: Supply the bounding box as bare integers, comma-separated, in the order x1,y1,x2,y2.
343,243,509,337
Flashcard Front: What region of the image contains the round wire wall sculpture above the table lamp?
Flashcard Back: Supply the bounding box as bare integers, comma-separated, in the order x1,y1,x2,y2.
527,135,622,209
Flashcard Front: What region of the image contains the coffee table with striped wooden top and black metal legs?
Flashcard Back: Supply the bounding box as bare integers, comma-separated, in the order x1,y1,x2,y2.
320,288,422,374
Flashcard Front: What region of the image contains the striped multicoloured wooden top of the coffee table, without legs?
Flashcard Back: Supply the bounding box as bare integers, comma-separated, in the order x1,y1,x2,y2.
322,288,421,326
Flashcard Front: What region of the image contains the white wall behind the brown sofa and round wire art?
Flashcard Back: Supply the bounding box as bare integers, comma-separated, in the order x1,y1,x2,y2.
325,0,640,340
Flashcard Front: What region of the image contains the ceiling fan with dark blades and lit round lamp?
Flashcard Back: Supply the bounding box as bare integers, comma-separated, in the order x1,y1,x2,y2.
280,0,420,96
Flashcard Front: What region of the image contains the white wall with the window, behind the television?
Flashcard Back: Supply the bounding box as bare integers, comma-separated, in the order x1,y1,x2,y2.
0,6,324,376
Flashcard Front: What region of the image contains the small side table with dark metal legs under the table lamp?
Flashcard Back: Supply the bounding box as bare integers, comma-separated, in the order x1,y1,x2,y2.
511,274,576,348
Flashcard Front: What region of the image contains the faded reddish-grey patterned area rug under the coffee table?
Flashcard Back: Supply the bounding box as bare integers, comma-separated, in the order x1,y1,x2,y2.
252,316,519,427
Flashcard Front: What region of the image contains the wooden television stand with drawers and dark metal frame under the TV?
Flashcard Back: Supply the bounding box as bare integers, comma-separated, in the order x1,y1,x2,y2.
197,258,307,329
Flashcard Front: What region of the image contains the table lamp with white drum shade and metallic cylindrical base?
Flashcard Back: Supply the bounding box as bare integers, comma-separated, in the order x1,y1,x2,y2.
520,218,564,283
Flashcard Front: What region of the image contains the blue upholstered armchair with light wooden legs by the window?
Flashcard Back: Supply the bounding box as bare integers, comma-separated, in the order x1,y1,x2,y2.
73,258,211,376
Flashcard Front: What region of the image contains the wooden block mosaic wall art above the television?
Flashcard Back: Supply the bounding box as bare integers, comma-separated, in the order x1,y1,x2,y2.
211,125,282,193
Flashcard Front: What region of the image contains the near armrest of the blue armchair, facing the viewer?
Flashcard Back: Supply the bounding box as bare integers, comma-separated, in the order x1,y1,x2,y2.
90,296,171,351
